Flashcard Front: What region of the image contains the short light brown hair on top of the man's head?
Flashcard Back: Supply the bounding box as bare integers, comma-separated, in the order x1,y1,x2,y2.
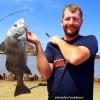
62,4,83,18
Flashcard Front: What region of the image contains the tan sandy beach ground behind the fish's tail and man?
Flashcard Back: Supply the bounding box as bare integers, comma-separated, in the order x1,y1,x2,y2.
0,80,100,100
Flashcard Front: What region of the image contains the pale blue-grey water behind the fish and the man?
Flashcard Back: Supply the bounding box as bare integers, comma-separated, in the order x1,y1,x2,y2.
0,54,100,78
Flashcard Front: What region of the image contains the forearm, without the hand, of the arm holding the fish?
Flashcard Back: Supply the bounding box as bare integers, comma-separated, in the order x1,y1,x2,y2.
36,42,52,80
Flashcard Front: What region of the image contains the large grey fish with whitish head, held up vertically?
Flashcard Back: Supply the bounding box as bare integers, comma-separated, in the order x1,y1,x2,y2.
0,18,32,96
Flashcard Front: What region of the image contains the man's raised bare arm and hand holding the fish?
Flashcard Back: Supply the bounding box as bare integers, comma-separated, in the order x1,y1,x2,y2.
27,32,53,80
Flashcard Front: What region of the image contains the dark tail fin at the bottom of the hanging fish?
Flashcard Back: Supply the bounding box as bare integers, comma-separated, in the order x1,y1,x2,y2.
14,84,31,96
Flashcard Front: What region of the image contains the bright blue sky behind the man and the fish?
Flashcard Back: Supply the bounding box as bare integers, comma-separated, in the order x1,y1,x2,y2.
0,0,100,54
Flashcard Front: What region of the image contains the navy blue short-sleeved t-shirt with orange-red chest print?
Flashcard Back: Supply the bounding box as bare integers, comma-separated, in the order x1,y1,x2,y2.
45,35,98,100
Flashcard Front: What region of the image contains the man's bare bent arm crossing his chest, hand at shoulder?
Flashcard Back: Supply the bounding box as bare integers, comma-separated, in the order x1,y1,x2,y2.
50,36,90,65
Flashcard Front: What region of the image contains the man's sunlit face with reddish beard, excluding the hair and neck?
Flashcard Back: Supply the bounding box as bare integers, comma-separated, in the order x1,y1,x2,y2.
61,9,82,37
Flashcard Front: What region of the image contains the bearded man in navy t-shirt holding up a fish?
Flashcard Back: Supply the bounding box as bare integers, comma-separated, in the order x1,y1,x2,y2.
27,4,98,100
